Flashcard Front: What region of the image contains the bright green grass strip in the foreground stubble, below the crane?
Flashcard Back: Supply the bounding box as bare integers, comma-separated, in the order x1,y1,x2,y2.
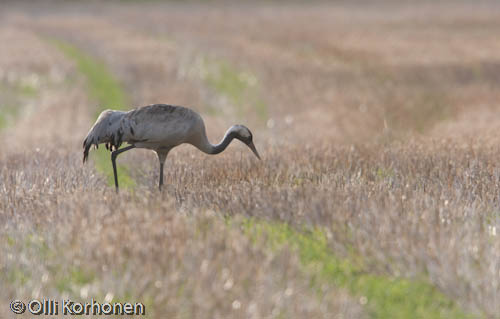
242,219,469,318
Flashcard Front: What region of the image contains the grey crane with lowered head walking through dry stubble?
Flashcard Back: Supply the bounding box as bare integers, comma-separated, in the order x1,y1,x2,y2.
83,104,260,191
